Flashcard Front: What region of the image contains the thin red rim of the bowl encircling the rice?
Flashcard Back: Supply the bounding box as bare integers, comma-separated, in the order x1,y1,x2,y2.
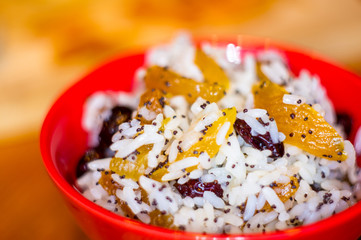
40,35,361,240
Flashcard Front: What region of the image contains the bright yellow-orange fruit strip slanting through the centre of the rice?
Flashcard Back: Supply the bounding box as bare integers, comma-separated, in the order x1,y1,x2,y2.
150,107,237,181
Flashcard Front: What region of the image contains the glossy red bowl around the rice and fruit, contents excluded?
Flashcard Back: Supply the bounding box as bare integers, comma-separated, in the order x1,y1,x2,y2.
40,37,361,240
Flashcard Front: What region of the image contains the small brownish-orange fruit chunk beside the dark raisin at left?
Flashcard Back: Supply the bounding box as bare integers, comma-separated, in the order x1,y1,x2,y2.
136,89,169,124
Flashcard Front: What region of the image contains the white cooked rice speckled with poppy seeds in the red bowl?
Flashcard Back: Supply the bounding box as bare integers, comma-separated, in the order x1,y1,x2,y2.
77,36,361,234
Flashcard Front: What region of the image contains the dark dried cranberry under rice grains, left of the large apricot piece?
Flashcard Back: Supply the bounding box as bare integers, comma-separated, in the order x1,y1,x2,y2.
234,119,285,159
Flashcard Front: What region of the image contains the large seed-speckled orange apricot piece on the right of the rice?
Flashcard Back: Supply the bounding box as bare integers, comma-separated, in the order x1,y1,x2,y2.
253,75,347,161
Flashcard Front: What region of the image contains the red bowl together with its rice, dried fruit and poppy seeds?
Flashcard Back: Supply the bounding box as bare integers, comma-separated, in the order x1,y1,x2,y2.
41,34,360,239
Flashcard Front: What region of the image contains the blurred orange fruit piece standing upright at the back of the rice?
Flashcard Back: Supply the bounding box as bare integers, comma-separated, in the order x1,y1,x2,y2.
194,48,229,89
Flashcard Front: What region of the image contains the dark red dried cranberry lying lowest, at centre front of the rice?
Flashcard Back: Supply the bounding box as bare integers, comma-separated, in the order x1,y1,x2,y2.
174,179,223,198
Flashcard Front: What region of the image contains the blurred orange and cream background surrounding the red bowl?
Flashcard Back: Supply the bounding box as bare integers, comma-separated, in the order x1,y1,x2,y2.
0,0,361,239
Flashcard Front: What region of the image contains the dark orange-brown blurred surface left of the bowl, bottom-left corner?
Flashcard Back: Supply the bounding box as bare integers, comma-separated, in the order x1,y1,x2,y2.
0,133,87,240
